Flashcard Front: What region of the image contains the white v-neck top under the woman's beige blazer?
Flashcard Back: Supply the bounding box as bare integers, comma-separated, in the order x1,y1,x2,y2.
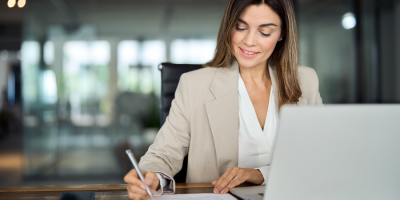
238,75,279,184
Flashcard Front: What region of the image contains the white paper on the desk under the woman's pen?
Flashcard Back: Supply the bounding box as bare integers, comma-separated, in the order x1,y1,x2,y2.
147,193,236,200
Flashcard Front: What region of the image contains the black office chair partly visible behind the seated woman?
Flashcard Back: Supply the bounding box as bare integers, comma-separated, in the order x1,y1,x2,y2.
158,63,202,183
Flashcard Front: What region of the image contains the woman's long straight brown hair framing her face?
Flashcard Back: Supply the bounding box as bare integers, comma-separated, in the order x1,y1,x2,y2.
205,0,302,108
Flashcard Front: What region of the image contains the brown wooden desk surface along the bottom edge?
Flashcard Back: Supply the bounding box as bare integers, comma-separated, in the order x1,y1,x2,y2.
0,183,239,200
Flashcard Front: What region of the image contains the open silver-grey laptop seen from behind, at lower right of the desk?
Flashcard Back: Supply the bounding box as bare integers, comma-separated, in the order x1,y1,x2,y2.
231,105,400,200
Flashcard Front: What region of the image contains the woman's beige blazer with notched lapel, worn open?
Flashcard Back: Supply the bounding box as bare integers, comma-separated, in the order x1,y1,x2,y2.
139,62,322,191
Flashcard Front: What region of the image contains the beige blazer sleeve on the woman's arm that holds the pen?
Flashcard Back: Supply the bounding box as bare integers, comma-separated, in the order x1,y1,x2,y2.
139,74,190,192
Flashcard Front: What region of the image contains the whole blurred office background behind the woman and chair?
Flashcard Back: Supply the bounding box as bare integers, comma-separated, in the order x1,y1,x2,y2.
0,0,400,186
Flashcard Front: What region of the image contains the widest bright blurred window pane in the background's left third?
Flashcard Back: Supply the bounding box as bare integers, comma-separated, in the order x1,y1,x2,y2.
63,41,111,126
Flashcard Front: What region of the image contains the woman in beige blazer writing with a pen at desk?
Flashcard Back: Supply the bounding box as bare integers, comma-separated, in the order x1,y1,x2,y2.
125,0,322,199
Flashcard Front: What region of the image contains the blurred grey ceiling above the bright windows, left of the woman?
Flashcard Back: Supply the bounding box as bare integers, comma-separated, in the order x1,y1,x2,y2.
24,0,228,38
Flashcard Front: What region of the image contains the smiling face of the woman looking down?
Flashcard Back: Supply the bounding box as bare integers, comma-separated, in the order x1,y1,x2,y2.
232,4,281,68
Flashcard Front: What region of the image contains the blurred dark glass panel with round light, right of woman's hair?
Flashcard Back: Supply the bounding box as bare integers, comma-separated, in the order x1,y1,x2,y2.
297,0,356,103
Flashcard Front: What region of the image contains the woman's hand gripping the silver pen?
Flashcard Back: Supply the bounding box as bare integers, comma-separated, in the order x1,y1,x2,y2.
124,169,160,200
